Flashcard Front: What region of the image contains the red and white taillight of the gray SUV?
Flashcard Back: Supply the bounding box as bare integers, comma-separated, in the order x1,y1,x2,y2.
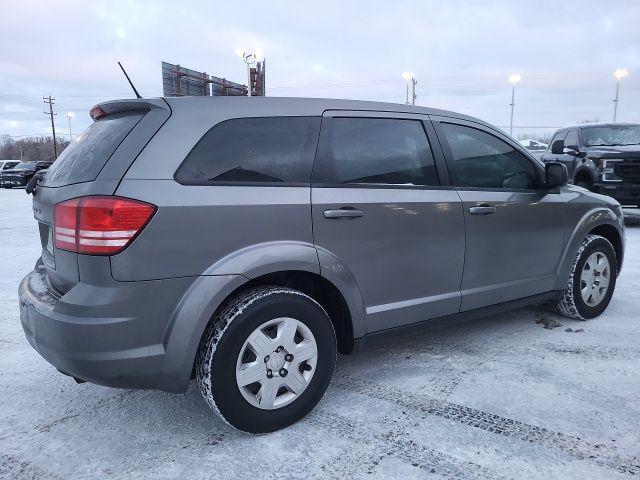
54,196,156,255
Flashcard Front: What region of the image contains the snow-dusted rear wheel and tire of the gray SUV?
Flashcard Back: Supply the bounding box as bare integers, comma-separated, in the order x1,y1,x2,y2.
196,286,337,433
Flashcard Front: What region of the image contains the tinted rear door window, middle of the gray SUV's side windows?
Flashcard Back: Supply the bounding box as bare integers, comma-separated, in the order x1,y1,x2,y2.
314,118,439,186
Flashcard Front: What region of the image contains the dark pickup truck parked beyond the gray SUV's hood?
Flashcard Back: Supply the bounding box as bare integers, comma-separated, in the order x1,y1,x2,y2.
542,123,640,205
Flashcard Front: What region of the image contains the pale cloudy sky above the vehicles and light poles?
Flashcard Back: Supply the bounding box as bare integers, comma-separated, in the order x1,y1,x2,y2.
0,0,640,141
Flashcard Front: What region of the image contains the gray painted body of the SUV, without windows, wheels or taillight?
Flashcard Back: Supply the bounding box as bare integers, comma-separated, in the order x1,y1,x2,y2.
20,98,624,391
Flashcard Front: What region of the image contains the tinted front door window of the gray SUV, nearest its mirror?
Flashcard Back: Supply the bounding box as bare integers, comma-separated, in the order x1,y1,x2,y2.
441,123,539,190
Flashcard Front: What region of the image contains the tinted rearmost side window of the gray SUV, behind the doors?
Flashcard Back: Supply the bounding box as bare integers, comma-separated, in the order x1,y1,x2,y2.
175,117,320,185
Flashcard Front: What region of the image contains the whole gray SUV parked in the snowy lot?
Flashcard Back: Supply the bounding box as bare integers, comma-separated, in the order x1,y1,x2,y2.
19,97,624,433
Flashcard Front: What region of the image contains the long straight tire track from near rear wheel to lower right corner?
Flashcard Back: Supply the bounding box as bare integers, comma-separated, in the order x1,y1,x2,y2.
332,375,640,475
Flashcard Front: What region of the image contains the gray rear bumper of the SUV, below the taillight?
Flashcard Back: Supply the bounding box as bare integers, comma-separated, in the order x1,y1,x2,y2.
19,264,193,392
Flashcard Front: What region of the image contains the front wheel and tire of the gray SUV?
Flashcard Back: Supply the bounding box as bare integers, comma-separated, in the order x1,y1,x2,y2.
556,235,618,320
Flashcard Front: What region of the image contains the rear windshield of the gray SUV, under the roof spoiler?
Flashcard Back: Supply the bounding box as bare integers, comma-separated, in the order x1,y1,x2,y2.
43,112,144,187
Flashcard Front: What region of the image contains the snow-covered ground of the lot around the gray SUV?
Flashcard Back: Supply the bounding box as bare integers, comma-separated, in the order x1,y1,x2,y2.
0,190,640,480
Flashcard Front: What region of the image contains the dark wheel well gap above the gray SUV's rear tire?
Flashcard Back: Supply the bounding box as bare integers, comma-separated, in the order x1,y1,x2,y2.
225,270,354,354
